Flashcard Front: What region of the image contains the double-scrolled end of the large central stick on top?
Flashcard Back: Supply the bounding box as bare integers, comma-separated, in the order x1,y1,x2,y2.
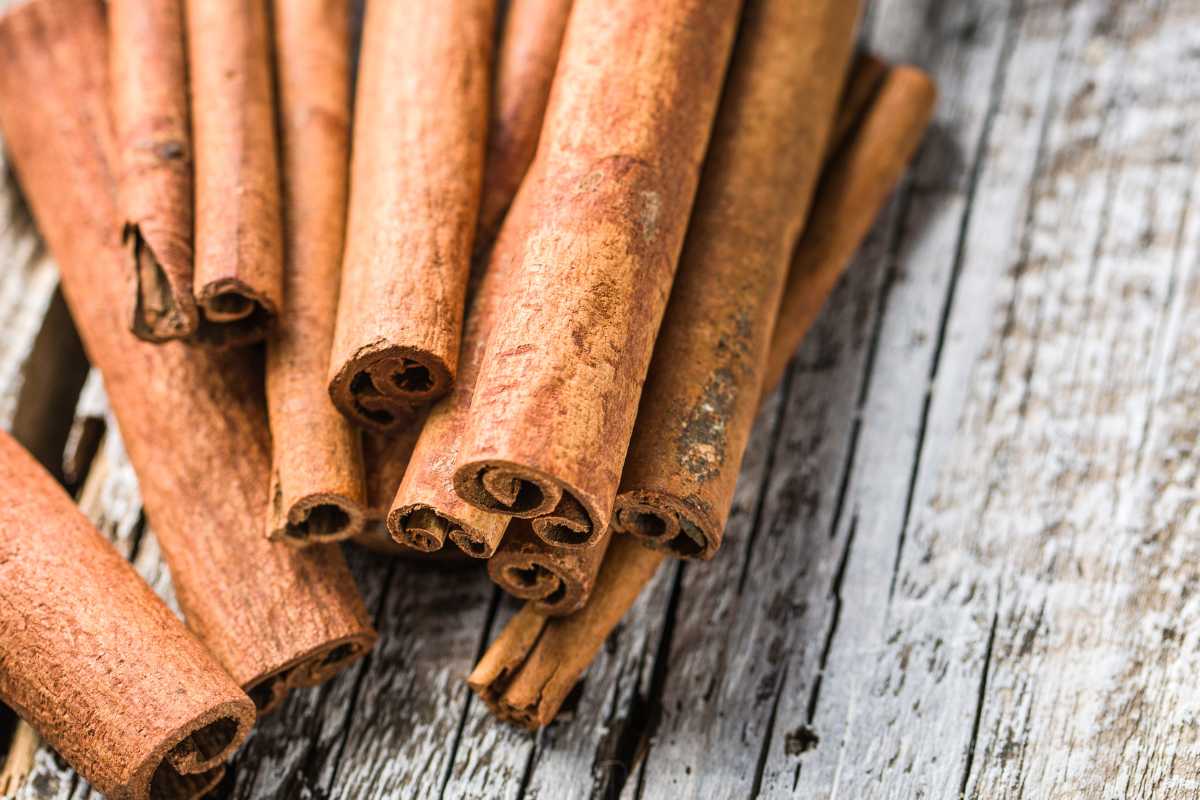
454,459,604,548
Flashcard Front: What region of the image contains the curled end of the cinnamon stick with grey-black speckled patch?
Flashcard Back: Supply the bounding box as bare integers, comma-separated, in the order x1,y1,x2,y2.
611,491,722,560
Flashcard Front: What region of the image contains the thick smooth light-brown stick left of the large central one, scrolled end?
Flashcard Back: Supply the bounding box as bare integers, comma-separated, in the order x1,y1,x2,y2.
329,0,496,431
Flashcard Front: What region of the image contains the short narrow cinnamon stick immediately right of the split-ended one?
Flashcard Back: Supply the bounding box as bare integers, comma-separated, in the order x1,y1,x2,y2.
186,0,283,347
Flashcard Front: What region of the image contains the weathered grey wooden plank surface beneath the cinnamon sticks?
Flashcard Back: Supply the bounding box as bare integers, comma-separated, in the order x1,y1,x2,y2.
0,0,1200,800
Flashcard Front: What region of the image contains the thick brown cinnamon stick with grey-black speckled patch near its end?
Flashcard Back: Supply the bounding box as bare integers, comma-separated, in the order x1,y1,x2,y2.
612,0,860,559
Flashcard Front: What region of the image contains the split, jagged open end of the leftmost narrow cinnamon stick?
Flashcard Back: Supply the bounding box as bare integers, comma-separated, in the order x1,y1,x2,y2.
121,222,199,343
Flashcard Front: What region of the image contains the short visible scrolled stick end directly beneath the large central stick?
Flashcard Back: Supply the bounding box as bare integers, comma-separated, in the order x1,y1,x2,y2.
487,519,611,616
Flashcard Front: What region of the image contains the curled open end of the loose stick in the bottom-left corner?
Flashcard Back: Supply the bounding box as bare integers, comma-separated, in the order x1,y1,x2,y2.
141,697,254,800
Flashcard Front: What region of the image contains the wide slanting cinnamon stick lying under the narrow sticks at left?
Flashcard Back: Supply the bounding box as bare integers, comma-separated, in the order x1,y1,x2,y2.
0,0,374,709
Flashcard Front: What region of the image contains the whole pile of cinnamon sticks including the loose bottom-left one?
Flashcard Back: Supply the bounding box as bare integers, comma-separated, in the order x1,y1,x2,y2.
0,0,935,798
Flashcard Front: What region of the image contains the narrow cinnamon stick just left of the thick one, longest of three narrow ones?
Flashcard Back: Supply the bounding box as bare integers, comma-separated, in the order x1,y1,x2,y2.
266,0,366,546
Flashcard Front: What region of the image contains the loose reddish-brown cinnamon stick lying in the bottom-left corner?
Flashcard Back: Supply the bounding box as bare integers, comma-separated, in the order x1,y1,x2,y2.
0,431,254,799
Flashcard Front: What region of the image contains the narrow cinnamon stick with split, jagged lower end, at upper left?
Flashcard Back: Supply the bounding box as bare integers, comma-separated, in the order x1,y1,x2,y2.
108,0,199,342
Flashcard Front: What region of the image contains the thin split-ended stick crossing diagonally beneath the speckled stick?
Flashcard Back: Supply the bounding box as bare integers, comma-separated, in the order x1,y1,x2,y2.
468,67,935,728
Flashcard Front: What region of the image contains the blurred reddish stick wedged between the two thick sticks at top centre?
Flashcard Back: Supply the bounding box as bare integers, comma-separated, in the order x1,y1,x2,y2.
475,0,571,252
